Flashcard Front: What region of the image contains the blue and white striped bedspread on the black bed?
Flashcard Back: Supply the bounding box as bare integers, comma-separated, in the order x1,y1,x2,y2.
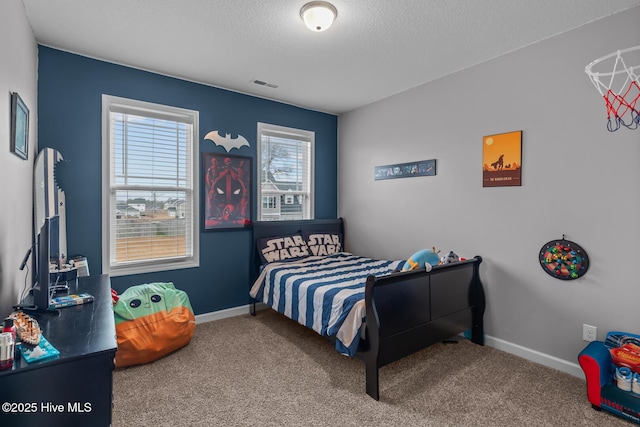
250,252,404,357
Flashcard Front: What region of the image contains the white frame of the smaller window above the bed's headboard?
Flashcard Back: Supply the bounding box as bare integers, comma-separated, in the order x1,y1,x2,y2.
256,122,315,221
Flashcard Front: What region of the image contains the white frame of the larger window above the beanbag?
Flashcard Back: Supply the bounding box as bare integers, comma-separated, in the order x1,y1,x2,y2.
101,94,200,276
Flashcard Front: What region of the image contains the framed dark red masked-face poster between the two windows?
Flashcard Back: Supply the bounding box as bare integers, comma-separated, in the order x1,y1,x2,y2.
202,153,251,230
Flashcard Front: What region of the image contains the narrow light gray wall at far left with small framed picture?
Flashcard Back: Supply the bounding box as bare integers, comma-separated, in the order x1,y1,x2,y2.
0,0,37,315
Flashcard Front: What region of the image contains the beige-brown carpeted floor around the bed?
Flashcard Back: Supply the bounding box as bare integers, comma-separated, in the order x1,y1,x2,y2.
113,310,633,427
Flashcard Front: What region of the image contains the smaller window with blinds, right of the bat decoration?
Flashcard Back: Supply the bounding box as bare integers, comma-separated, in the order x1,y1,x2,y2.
258,123,315,221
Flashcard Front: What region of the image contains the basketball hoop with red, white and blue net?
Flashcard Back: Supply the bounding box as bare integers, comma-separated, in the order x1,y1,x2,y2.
584,46,640,132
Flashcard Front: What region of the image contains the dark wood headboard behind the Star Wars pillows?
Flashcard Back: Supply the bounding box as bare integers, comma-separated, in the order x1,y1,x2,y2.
249,218,344,286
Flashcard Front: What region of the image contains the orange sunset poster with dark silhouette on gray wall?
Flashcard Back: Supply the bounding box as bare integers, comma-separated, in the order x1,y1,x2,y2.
482,130,522,187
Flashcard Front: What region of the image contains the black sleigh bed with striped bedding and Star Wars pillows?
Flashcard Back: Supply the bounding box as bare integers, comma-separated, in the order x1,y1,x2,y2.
250,219,485,400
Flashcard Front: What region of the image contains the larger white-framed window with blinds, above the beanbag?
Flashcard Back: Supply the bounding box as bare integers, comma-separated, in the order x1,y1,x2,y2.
102,95,199,275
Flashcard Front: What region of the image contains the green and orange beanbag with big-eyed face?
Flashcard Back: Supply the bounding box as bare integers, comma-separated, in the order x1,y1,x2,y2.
113,283,196,368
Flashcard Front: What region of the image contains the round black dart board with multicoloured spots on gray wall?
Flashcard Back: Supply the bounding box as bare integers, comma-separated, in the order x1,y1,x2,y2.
538,236,589,280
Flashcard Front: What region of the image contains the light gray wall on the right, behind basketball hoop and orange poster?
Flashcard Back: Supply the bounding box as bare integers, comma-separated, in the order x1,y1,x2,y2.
338,7,640,375
